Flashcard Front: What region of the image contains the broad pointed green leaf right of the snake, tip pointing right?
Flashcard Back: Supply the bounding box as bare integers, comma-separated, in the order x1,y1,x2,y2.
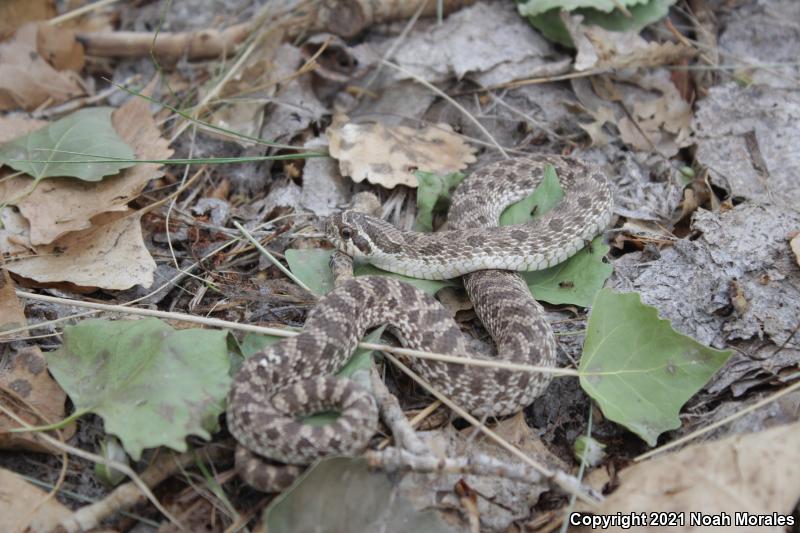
578,289,731,446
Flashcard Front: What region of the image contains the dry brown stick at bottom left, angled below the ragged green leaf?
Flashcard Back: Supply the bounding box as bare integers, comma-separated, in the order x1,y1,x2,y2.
60,444,231,531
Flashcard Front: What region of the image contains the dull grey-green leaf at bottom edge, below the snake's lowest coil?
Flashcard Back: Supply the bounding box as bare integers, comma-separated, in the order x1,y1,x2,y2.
264,457,458,533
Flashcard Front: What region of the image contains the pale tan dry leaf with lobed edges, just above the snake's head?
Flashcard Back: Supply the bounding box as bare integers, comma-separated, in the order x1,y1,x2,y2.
327,117,475,189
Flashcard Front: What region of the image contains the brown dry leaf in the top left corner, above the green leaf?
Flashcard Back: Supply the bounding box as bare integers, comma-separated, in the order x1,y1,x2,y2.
0,23,85,110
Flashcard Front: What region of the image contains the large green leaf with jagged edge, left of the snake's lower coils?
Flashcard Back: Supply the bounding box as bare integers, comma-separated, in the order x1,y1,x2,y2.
46,318,231,460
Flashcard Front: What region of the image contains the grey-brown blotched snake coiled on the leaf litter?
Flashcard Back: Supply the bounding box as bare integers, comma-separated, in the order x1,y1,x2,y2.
226,155,613,492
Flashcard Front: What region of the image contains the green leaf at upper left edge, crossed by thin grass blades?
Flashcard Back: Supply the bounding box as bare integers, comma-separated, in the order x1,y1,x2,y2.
0,107,136,181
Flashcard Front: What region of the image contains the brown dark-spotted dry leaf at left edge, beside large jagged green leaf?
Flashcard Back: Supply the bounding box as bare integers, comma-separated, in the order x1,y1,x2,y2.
0,346,75,453
